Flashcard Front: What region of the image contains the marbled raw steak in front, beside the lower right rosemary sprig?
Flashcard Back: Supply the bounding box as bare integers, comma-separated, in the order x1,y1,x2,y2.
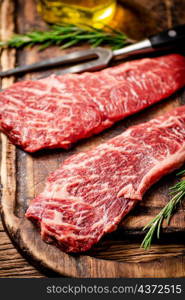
26,106,185,252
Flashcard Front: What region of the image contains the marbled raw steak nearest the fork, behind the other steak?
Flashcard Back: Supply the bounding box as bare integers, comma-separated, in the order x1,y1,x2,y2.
0,54,185,152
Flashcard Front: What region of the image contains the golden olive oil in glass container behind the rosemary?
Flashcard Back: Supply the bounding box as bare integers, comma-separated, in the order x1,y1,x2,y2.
38,0,116,28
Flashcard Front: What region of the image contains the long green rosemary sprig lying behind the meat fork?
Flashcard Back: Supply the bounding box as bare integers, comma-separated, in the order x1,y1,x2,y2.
0,24,133,50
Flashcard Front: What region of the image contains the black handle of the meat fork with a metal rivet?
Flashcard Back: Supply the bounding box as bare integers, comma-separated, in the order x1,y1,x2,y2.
149,24,185,49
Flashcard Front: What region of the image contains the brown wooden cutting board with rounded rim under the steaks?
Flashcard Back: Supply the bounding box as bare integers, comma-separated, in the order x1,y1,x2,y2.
1,0,185,277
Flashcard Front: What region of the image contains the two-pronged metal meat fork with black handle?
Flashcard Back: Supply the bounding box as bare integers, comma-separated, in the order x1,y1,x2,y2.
0,24,185,77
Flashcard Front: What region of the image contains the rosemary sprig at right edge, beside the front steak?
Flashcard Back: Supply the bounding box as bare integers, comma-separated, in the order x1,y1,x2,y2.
141,170,185,250
